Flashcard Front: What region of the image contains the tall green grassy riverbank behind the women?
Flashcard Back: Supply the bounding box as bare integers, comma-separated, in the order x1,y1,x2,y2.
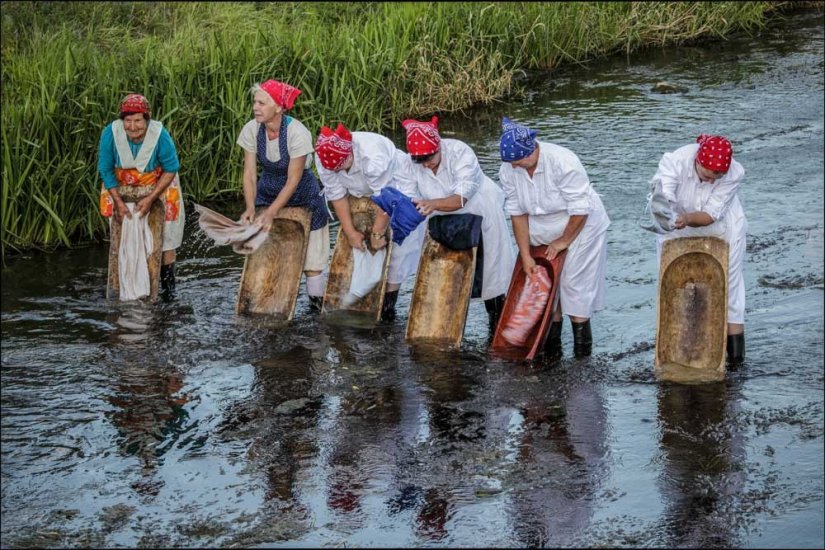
2,2,816,261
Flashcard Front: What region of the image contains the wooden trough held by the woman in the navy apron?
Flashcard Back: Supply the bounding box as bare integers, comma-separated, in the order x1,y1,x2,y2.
235,206,312,321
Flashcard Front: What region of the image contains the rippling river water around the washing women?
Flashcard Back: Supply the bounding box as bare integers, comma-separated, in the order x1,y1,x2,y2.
0,9,825,548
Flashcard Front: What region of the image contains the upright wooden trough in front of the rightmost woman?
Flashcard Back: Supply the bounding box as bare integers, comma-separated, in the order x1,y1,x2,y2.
656,237,728,382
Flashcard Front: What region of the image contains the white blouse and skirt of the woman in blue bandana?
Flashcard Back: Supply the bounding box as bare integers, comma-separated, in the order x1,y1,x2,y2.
496,141,610,319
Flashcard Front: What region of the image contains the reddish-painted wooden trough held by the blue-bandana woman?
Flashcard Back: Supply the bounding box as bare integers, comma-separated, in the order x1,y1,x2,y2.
491,245,567,360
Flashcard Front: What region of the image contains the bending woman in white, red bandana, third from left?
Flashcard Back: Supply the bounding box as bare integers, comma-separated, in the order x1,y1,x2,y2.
315,124,424,321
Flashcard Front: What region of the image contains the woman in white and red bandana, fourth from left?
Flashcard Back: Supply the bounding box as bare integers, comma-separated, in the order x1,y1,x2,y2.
398,117,515,334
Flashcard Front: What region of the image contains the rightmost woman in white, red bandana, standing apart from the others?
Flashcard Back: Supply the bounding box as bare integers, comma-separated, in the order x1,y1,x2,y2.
652,134,748,365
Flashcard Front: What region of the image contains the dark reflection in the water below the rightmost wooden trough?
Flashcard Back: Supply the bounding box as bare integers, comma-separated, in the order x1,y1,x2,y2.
658,382,745,548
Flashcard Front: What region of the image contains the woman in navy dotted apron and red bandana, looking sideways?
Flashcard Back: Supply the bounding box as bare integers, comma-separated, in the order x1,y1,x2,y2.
237,80,329,311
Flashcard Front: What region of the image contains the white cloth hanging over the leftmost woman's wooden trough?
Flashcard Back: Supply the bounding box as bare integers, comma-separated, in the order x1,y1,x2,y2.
117,202,154,301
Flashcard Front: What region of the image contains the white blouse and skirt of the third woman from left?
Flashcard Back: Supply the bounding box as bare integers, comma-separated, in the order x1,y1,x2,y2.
315,132,426,284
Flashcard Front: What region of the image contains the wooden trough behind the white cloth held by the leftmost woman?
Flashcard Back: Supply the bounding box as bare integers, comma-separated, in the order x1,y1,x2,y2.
106,185,166,301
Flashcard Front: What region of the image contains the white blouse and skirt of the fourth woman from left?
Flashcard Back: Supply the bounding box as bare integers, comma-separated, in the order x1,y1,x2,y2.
395,138,516,300
